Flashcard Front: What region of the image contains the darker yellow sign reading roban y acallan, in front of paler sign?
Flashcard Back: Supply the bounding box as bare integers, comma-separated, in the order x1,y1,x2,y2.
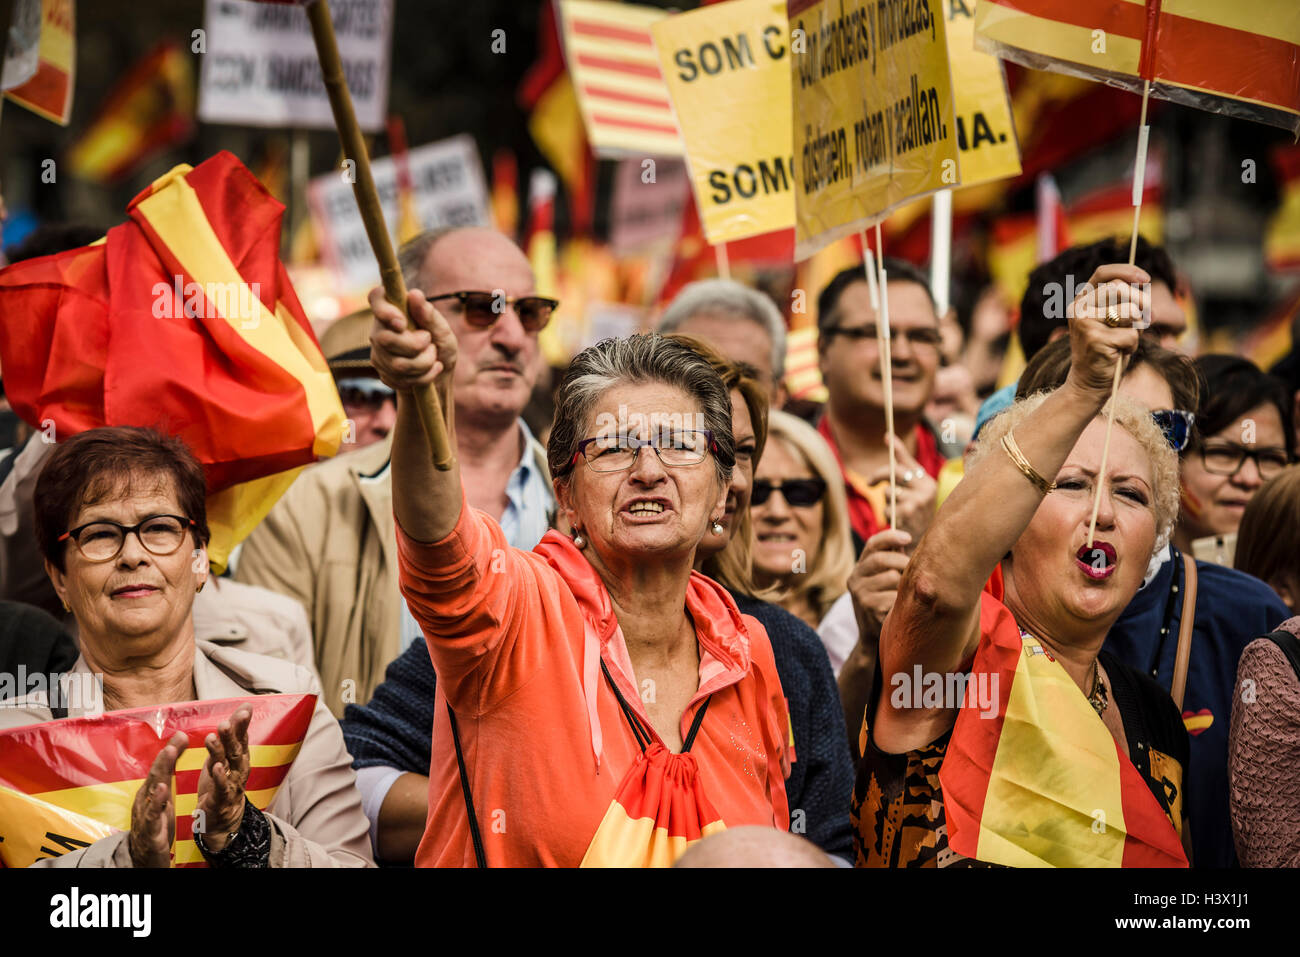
788,0,962,259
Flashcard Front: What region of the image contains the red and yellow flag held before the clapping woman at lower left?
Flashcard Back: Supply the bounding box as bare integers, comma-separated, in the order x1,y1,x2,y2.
0,694,316,867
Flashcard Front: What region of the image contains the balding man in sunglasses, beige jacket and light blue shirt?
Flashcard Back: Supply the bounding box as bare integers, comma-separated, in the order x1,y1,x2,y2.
235,228,554,718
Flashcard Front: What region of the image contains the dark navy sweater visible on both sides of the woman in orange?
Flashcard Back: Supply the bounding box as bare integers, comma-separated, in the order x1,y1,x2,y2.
341,587,853,861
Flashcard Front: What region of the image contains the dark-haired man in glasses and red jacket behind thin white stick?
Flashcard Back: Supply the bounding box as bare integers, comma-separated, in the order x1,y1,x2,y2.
816,257,944,550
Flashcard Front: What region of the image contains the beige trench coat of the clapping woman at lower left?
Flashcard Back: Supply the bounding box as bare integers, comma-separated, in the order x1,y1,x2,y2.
0,641,374,867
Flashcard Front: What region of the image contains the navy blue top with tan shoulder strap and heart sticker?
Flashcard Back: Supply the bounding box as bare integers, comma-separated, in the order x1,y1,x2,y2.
1105,549,1291,867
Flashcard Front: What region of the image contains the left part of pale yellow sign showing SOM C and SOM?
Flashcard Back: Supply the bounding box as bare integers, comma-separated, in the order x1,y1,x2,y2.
650,0,794,244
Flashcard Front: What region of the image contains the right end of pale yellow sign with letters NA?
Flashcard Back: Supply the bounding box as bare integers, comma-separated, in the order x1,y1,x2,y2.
944,0,1021,186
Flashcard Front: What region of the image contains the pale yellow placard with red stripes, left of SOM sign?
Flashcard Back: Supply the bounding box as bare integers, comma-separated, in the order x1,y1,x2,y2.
559,0,683,159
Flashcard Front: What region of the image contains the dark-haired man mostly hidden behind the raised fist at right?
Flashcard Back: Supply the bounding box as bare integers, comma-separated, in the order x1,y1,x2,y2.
1017,235,1187,361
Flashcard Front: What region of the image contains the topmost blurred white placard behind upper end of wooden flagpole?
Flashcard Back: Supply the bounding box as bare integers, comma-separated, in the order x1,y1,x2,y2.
199,0,393,133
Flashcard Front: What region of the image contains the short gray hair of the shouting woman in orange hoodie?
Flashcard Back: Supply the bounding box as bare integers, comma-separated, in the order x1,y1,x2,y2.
546,333,736,485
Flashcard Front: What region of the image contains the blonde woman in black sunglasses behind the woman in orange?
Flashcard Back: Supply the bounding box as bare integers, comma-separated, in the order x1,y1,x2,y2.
750,411,853,628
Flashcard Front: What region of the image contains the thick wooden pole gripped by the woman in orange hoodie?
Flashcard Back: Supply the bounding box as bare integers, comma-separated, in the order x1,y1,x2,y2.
307,0,454,472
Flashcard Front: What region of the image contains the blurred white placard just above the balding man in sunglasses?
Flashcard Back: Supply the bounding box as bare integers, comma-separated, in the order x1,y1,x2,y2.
307,134,491,289
